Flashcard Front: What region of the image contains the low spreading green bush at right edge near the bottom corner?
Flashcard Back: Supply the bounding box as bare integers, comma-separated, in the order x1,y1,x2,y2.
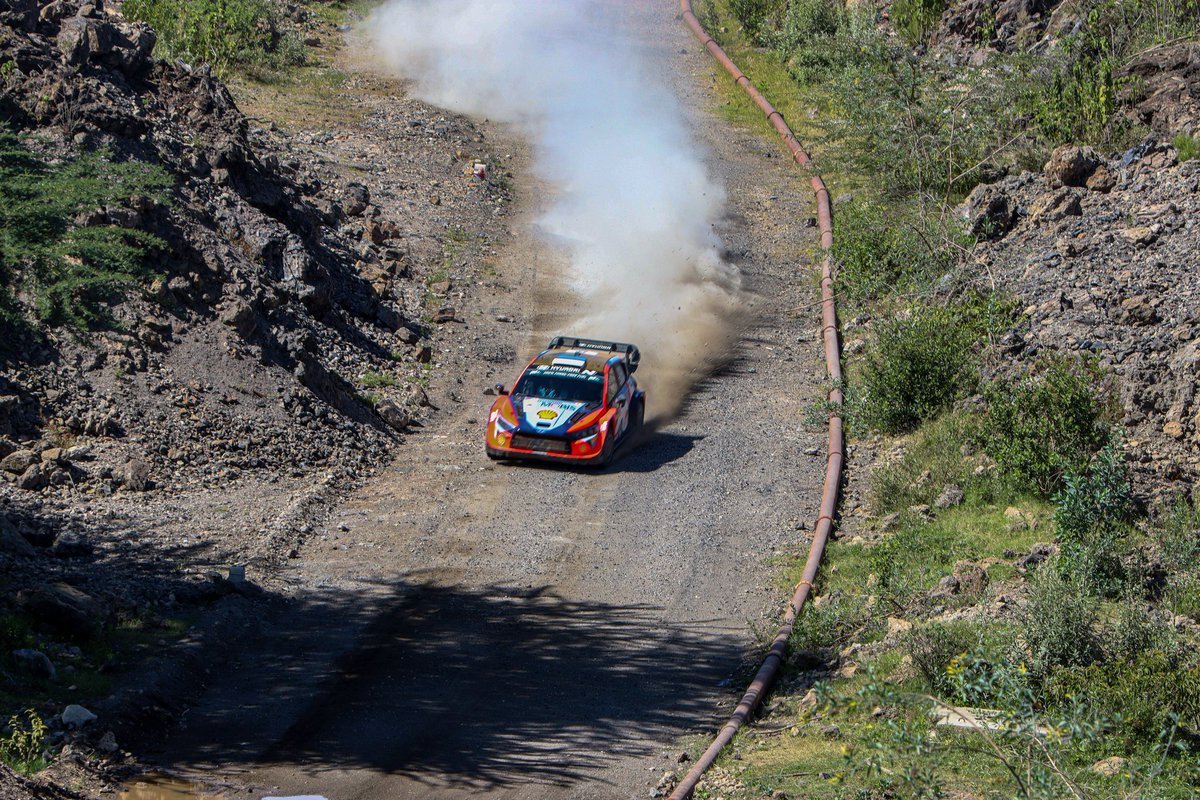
1044,650,1200,740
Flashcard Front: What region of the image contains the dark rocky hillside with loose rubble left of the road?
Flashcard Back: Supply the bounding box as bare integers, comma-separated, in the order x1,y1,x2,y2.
0,0,511,792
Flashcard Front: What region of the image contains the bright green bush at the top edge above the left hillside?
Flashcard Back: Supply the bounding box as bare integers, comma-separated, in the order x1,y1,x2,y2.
124,0,304,72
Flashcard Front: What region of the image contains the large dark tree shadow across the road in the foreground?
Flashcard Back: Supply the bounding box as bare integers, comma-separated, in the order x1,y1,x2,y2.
147,583,745,796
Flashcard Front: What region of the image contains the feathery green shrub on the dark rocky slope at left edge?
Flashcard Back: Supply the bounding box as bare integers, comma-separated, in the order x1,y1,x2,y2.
0,134,172,327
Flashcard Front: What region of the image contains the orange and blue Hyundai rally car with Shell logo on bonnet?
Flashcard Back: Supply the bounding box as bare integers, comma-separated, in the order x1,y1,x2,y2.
487,336,646,467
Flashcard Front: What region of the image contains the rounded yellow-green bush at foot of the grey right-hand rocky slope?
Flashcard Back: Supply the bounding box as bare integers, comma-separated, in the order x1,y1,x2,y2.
980,356,1110,497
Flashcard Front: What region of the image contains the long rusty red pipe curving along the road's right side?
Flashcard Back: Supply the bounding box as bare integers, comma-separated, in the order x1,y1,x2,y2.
668,0,846,800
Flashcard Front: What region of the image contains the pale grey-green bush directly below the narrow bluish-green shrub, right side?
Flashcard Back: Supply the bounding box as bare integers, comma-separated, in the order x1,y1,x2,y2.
1024,567,1102,680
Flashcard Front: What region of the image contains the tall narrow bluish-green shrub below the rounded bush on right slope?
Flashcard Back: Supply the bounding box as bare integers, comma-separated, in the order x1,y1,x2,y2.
1055,435,1133,596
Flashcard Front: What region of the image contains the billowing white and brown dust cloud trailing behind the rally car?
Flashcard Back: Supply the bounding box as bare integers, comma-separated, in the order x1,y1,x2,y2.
370,0,739,420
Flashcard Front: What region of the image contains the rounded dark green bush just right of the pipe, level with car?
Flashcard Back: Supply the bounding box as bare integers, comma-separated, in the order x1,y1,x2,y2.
859,306,977,433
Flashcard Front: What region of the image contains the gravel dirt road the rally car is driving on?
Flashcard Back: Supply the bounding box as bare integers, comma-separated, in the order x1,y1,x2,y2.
147,0,823,800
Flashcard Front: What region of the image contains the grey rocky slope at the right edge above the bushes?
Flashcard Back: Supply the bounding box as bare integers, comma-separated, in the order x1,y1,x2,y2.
960,139,1200,500
